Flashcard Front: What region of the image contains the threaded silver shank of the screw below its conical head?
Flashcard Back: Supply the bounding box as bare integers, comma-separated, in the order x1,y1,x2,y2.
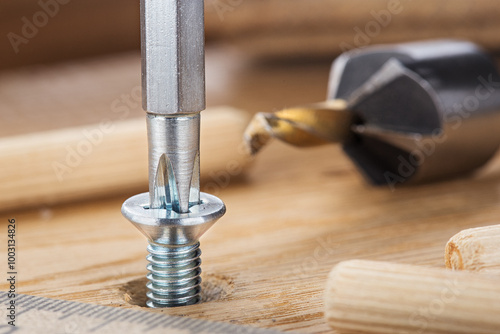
146,242,201,308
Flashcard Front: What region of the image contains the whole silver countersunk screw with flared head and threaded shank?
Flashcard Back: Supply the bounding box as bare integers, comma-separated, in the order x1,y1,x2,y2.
122,193,226,308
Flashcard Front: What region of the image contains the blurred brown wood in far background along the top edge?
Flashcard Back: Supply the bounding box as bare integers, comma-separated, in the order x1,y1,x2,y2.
0,0,500,68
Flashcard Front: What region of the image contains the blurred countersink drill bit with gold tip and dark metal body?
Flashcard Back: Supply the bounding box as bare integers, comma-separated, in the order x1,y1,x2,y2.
245,40,500,188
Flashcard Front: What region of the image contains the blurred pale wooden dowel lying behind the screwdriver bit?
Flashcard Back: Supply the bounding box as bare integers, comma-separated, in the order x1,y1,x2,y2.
0,107,249,210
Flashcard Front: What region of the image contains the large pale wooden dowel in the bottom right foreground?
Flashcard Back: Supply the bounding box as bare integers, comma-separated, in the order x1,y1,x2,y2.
325,260,500,334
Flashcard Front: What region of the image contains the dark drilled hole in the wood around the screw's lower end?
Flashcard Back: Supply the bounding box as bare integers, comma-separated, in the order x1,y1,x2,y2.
120,274,234,307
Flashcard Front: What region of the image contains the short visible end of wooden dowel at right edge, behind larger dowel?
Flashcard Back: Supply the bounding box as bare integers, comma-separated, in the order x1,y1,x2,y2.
445,225,500,273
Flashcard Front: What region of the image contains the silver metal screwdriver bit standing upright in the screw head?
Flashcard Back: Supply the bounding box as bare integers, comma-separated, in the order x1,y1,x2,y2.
141,0,205,212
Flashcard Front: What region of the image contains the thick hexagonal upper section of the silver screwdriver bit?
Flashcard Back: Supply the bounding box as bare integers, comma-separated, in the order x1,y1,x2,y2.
141,0,205,115
